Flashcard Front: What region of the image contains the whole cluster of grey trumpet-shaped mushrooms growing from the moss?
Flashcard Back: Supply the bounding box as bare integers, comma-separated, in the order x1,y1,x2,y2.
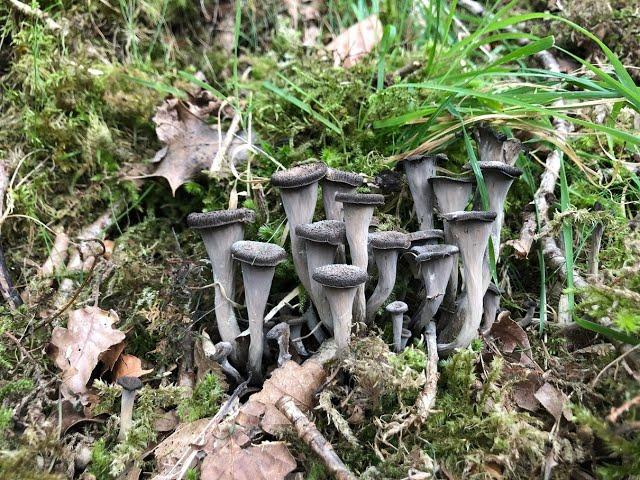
187,127,521,383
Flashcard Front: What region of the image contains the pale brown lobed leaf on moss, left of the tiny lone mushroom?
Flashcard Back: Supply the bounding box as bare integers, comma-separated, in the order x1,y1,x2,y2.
51,307,125,397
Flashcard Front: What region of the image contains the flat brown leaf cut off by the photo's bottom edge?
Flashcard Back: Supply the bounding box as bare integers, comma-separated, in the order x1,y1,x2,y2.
200,441,296,480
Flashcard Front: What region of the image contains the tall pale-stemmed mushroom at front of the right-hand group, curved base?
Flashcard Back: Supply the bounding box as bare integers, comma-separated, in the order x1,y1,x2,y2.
438,211,496,354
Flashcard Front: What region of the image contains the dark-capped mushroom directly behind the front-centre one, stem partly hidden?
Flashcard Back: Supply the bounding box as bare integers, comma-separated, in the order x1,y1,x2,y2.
296,220,346,330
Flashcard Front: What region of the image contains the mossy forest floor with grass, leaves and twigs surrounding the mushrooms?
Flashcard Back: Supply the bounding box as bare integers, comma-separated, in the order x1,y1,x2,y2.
0,0,640,480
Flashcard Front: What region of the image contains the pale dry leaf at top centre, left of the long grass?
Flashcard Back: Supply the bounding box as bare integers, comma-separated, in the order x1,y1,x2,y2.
326,15,382,68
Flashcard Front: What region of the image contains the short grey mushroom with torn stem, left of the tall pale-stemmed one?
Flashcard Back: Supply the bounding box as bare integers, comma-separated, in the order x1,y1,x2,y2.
411,245,459,332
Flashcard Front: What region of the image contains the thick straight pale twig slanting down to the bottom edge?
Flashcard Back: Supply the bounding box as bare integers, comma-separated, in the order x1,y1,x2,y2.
276,395,356,480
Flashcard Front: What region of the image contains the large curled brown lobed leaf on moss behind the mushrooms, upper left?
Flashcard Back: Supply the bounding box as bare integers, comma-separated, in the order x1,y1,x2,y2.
150,90,248,195
